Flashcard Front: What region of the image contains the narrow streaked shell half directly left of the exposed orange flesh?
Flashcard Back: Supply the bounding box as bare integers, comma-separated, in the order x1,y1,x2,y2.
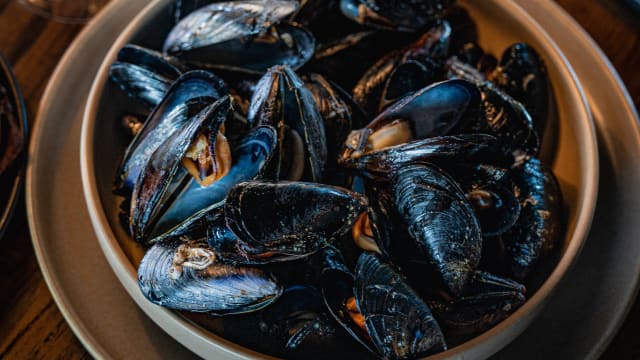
129,96,231,242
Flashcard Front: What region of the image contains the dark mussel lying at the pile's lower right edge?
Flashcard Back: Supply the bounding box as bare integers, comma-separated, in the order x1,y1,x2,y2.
426,271,526,337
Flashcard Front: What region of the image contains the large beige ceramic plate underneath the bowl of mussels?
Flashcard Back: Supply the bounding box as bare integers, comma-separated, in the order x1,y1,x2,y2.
26,0,640,358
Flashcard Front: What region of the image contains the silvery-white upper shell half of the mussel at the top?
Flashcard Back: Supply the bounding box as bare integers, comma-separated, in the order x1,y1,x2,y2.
162,0,298,54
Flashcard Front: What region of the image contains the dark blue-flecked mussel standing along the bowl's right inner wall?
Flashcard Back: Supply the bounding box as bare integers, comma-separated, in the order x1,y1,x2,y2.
501,158,564,280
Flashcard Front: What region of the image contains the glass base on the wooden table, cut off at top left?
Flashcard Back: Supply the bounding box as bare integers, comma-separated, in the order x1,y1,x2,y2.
18,0,109,24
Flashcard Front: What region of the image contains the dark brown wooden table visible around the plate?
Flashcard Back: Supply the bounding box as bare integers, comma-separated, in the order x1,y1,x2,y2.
0,0,640,359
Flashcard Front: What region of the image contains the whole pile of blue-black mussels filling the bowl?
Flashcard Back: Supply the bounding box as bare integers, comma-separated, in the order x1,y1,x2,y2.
110,0,563,358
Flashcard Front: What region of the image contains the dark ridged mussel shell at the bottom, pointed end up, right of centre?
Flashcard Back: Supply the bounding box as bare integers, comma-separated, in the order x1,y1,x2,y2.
354,252,447,359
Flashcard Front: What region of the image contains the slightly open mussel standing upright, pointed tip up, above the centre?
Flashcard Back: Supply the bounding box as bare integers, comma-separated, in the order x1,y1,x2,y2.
248,66,328,182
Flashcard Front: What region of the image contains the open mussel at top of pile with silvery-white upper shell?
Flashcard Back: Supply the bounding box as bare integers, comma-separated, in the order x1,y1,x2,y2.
163,0,315,74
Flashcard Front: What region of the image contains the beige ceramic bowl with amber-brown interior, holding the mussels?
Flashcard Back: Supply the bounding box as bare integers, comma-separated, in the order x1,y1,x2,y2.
81,0,598,359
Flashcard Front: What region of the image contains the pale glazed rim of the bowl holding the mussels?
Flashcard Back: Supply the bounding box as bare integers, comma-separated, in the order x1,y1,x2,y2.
80,0,599,359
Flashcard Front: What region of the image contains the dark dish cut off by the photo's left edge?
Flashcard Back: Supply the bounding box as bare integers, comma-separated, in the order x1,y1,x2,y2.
0,53,28,239
